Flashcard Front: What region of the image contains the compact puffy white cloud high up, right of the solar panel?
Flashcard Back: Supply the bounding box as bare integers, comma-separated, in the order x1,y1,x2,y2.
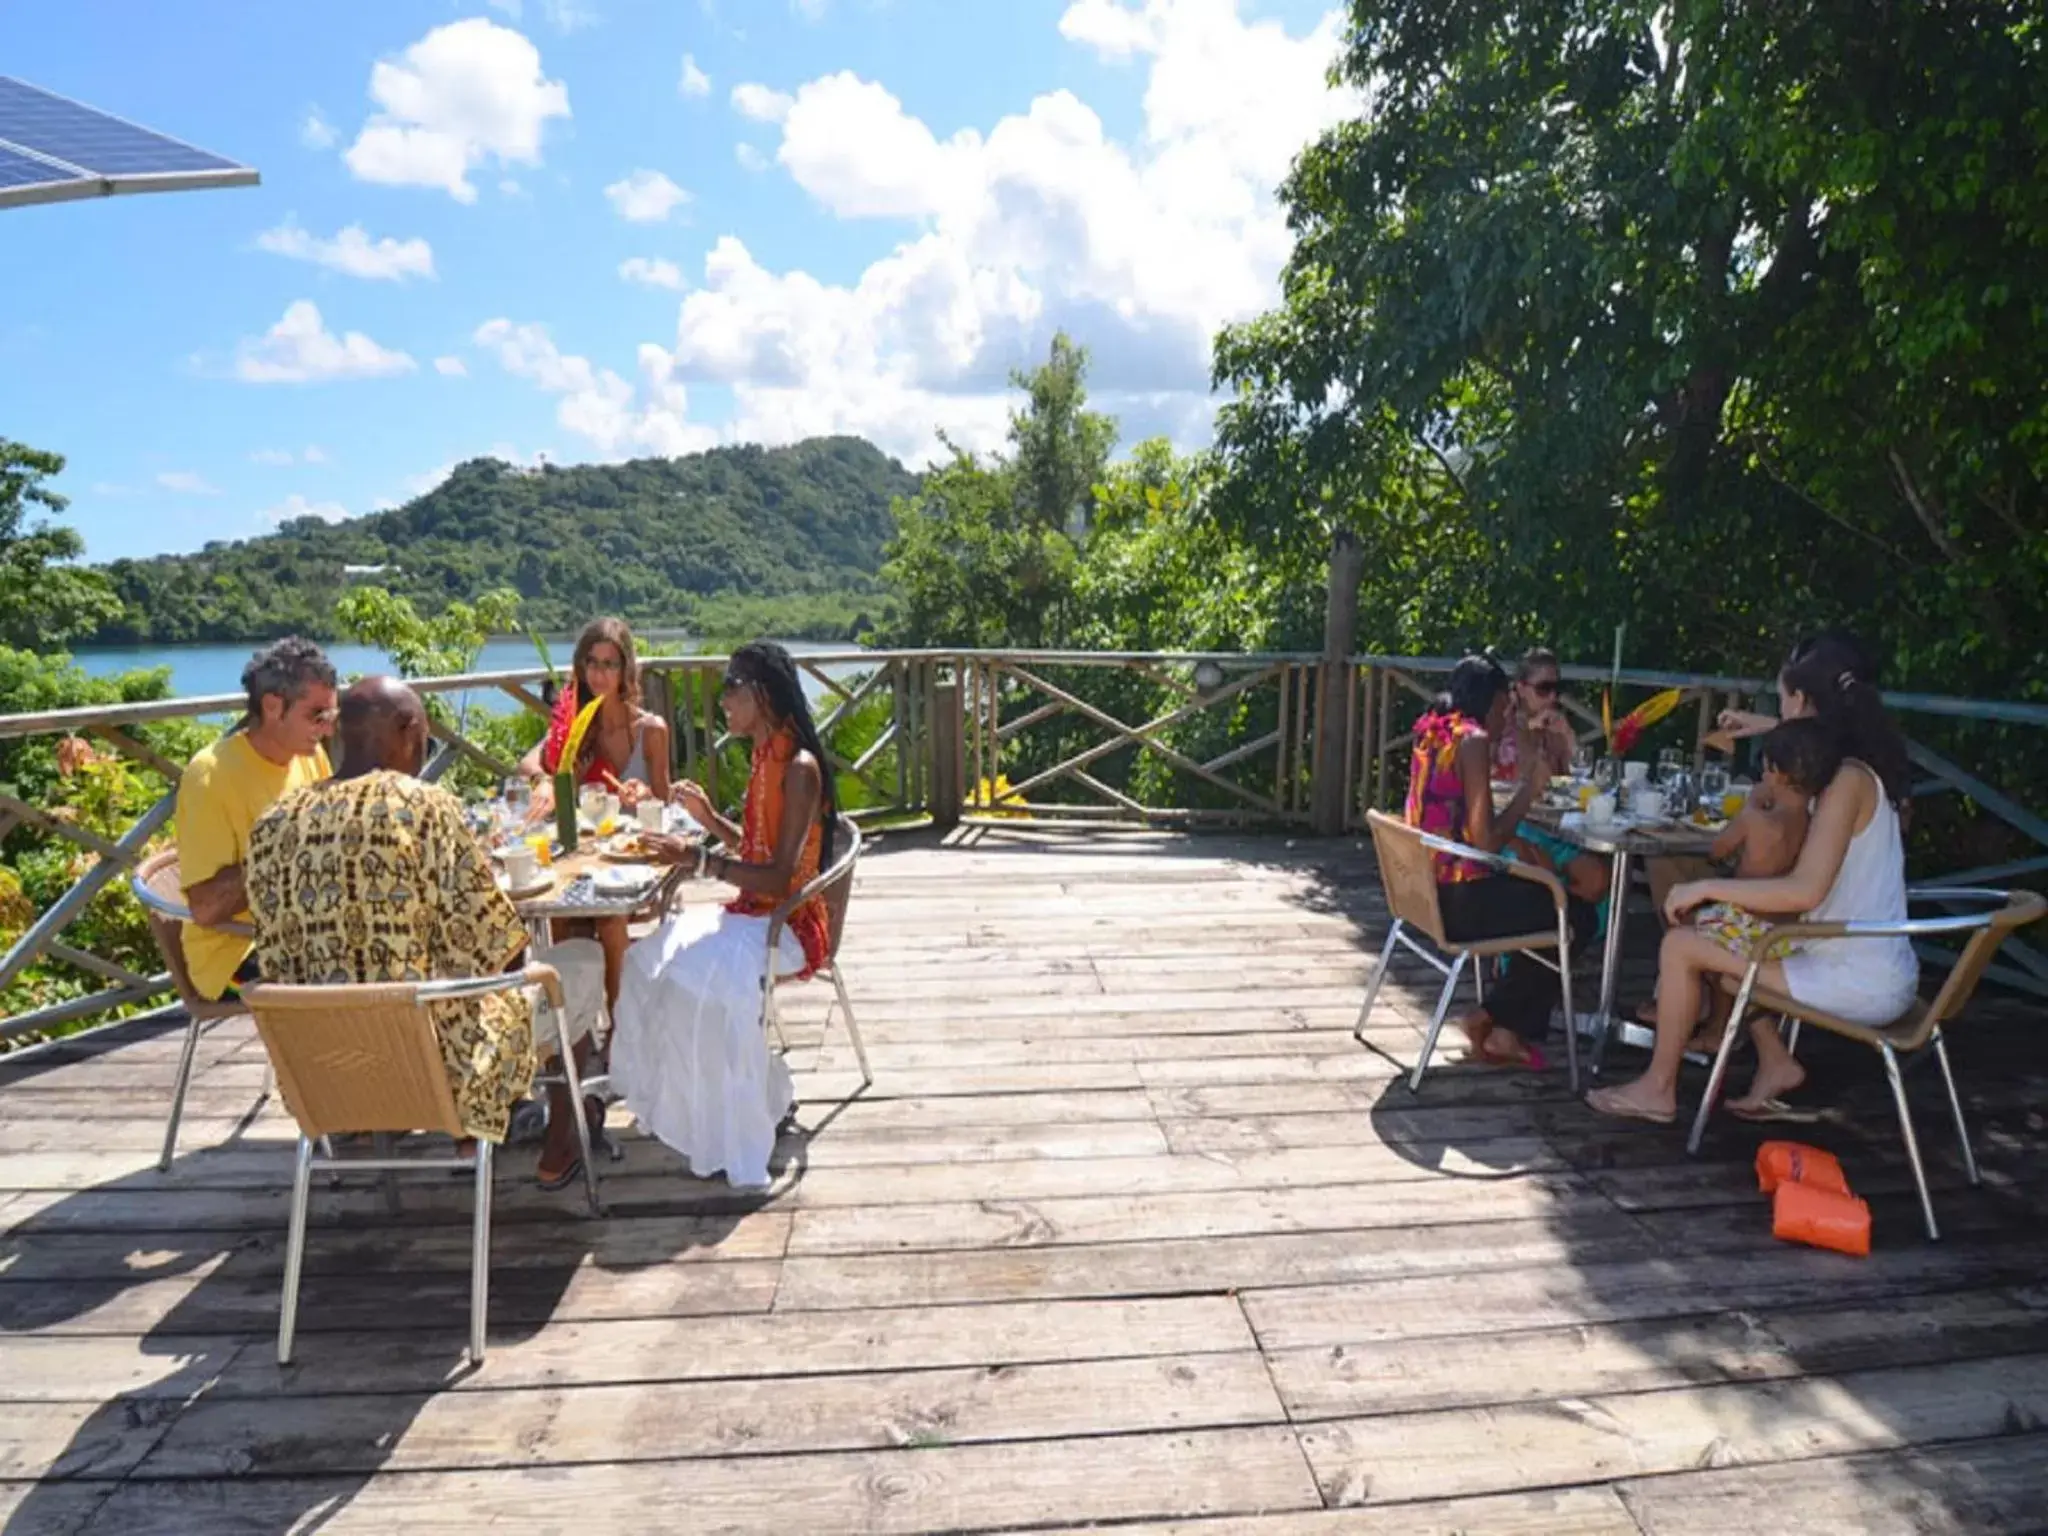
344,16,569,203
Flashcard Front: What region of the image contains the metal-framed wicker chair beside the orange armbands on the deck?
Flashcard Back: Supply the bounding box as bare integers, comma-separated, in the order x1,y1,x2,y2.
1686,887,2048,1241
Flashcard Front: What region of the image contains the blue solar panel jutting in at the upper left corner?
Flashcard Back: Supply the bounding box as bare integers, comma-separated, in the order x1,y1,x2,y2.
0,76,256,207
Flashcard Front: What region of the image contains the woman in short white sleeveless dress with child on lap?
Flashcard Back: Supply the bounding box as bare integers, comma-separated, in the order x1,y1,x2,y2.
1587,635,1919,1124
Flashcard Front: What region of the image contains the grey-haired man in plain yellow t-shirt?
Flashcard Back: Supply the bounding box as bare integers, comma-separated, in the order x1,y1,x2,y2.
178,639,336,997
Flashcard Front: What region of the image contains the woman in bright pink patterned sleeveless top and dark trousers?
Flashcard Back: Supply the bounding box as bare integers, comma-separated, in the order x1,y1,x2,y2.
1405,655,1593,1069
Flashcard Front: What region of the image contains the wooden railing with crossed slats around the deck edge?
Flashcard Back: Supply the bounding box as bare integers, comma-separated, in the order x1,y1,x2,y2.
12,651,2048,1040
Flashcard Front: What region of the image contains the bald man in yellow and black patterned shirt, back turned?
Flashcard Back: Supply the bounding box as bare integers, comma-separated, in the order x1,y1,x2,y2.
248,678,604,1184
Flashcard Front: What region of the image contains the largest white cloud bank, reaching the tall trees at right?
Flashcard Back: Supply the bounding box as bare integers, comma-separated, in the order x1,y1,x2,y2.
477,0,1362,463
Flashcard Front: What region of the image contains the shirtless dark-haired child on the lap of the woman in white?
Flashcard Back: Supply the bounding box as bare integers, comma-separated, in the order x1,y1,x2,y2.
1654,717,1841,1051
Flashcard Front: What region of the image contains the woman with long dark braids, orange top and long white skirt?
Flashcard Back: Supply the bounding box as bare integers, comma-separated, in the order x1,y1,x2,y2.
612,641,838,1188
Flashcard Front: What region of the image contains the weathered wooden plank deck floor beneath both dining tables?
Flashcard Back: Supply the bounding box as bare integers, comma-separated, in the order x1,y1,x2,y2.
0,831,2048,1536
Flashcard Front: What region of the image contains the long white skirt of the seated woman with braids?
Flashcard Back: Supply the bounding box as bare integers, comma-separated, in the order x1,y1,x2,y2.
612,907,803,1188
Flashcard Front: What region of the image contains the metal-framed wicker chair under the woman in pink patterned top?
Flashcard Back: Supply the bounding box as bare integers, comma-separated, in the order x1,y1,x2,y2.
1352,811,1579,1094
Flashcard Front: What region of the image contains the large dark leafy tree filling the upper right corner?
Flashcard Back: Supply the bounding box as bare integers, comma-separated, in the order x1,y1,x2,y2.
1217,0,2048,692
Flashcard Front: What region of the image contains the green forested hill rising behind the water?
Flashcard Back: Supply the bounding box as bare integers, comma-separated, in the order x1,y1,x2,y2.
92,438,920,643
